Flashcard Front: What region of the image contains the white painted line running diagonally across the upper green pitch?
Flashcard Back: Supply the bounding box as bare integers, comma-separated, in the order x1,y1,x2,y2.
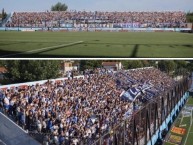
0,41,84,57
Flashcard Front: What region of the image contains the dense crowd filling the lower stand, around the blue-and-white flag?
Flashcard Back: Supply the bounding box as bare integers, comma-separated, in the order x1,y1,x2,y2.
0,68,175,145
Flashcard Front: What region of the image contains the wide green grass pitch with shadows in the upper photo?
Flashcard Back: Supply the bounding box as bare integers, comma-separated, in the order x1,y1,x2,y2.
0,31,193,58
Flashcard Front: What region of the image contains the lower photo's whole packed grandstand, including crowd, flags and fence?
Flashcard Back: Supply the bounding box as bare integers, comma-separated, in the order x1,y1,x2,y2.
0,67,192,145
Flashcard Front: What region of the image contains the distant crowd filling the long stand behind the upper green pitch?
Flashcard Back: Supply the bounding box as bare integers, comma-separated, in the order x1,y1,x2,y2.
7,11,186,27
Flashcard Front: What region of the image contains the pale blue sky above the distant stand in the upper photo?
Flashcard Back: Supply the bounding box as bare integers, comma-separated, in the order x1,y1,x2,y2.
0,0,193,13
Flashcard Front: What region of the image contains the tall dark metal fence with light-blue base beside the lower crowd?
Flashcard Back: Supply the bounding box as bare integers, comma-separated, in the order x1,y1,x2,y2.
92,78,192,145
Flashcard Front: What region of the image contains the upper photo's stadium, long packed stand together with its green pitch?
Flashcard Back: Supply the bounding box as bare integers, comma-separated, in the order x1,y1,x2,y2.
0,10,193,58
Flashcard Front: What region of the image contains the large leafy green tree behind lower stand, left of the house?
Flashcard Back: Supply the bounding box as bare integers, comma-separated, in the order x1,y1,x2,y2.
5,60,60,83
